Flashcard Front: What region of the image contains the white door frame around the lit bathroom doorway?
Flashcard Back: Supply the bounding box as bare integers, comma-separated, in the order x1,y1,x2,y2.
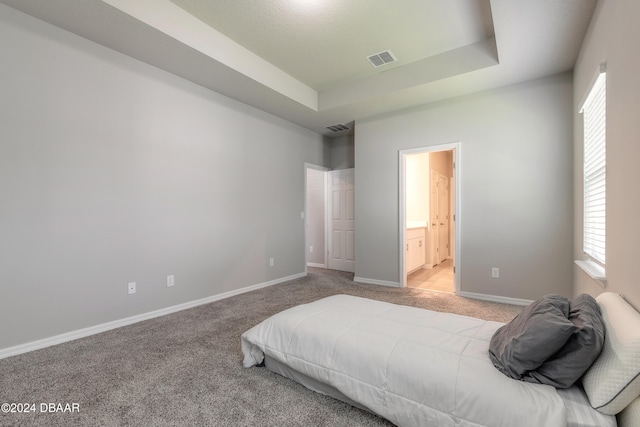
398,142,462,294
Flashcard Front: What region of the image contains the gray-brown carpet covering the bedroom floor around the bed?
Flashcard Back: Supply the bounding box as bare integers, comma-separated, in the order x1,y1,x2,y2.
0,269,522,426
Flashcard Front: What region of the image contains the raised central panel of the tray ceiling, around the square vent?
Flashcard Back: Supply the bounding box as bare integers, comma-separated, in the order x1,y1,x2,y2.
172,0,493,92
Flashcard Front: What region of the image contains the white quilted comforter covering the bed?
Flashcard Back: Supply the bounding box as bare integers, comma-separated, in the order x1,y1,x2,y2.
242,295,615,427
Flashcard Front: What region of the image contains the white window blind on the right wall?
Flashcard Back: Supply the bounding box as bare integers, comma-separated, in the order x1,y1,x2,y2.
581,67,607,265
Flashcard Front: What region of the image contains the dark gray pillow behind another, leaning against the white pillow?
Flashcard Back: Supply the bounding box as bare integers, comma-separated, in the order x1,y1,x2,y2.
524,294,605,388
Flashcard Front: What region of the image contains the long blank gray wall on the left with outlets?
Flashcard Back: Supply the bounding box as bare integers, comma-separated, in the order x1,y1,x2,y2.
0,5,330,349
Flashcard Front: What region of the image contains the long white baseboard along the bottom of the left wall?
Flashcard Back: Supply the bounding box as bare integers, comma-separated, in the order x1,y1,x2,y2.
0,273,306,359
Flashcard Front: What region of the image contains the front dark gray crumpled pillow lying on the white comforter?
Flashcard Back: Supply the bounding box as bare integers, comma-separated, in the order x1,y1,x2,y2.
489,295,576,380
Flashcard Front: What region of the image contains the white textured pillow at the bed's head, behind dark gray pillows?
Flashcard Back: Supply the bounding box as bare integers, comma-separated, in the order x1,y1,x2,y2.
582,292,640,415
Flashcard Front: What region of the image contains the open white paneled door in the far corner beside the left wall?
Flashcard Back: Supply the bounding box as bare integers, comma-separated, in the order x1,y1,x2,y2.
328,169,355,273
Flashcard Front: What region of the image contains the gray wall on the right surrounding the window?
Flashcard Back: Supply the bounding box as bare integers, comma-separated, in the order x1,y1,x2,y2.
573,0,640,308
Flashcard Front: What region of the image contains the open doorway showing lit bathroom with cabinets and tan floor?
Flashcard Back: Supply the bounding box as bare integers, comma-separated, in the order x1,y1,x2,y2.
399,143,460,292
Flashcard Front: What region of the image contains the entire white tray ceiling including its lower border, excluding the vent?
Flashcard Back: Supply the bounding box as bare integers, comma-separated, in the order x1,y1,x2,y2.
0,0,596,136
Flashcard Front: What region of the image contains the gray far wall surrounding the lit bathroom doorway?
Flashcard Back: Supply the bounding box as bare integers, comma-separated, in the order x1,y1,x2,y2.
355,73,573,299
